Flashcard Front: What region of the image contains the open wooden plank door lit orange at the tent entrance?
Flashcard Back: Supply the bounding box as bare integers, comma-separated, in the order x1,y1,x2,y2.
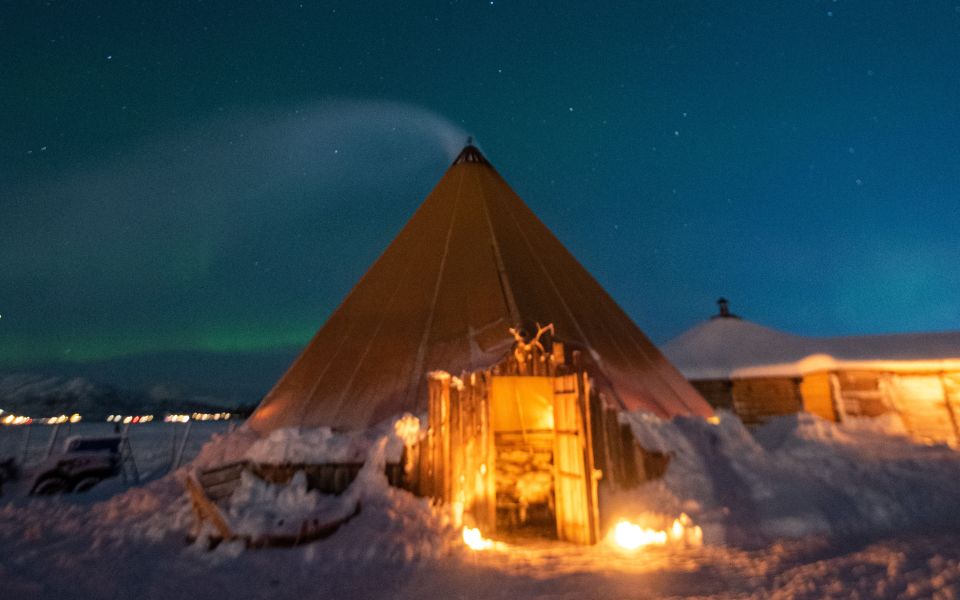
553,375,597,544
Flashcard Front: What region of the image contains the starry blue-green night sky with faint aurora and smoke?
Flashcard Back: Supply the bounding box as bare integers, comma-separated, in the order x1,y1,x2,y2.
0,0,960,384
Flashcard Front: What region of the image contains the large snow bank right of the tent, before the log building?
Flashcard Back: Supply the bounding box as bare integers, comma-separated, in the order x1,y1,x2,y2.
619,413,960,547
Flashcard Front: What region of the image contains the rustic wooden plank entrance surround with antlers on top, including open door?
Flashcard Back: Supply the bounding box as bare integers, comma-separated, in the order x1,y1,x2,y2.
408,329,669,544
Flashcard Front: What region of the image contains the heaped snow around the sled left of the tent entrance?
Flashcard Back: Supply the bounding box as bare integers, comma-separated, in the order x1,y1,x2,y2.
193,428,461,564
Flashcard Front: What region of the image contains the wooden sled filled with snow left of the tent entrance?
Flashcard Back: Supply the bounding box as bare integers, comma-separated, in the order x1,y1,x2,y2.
183,461,360,549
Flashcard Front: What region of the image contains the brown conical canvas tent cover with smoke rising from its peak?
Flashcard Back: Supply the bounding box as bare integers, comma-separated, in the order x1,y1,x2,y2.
249,145,712,431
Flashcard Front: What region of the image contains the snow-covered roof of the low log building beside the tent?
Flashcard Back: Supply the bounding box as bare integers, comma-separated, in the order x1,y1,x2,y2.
662,318,960,379
